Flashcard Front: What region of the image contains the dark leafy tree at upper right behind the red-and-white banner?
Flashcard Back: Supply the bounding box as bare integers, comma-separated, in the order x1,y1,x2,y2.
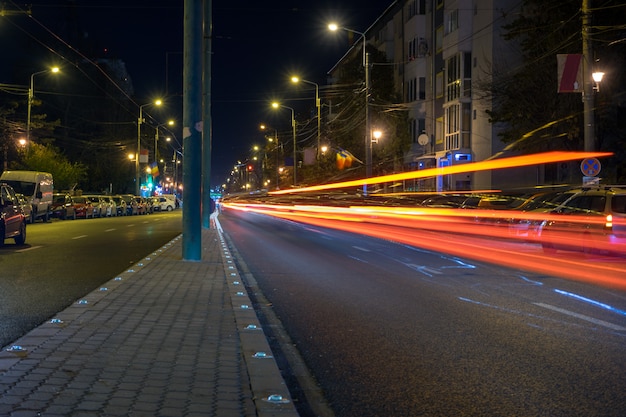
489,0,626,180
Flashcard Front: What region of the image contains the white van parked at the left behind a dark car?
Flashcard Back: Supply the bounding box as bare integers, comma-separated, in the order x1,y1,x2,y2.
0,171,54,223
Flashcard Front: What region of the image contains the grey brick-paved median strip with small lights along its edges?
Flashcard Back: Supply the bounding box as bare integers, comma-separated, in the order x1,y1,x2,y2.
0,229,297,417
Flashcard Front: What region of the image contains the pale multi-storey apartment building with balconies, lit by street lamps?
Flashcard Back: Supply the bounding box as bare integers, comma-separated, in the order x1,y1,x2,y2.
329,0,540,191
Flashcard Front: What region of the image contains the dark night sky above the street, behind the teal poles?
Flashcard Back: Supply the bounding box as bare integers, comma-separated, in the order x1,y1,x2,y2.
0,0,393,184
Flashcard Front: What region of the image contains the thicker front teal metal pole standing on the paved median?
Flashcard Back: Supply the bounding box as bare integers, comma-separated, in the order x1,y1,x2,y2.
183,0,203,261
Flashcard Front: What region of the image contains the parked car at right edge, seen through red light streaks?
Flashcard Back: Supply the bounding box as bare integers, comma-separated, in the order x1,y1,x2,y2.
541,186,626,256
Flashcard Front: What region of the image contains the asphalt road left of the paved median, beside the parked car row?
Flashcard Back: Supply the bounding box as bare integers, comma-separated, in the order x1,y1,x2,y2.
0,210,182,346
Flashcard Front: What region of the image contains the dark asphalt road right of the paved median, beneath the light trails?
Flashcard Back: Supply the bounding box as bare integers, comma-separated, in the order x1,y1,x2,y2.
219,211,626,417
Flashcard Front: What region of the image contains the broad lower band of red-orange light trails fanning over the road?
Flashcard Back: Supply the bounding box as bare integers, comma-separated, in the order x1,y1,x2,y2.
224,203,626,289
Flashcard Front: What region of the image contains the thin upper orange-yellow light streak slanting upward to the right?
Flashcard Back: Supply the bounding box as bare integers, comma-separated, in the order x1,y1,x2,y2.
269,152,612,195
